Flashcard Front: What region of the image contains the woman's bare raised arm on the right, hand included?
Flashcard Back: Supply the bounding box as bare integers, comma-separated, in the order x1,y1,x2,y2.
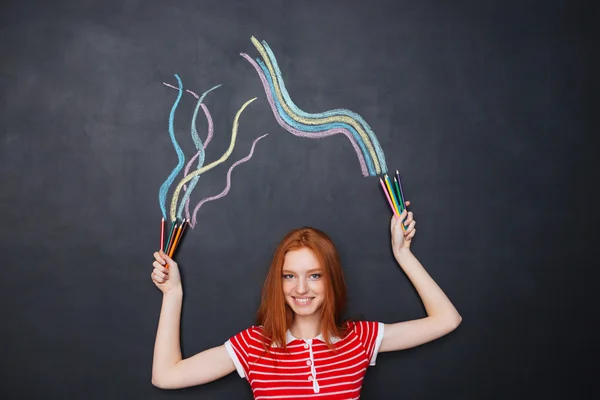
379,206,462,352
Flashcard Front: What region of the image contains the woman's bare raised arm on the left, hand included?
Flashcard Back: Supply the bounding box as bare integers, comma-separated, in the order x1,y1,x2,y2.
151,250,235,389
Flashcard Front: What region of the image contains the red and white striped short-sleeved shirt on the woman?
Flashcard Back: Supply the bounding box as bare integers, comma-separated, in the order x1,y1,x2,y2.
225,321,383,400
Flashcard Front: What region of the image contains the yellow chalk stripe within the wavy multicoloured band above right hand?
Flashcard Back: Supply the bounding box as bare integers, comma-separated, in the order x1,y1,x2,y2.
251,36,381,174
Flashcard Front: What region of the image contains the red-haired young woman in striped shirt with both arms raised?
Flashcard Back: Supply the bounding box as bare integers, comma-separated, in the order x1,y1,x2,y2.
151,202,461,400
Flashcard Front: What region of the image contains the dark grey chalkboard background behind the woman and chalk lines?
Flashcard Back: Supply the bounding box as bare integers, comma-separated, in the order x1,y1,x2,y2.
0,0,600,399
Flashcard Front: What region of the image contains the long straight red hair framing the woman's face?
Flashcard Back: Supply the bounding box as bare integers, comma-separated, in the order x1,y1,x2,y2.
256,227,346,351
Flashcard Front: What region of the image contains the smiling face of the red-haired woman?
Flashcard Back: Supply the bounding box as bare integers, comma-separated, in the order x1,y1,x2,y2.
281,247,326,317
